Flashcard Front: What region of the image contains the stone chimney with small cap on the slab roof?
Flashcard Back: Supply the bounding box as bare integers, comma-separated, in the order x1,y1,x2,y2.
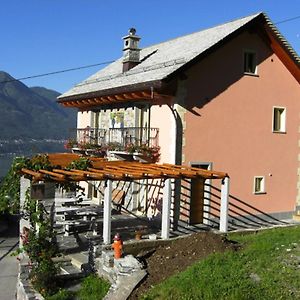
123,28,141,72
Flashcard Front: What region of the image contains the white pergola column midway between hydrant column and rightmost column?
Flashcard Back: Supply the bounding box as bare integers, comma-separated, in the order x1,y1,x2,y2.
161,179,172,239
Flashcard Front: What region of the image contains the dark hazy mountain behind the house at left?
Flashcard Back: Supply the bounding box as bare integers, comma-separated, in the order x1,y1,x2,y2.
0,71,76,140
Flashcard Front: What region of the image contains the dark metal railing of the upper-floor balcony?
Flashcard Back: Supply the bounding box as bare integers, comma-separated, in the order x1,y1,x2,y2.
71,127,159,148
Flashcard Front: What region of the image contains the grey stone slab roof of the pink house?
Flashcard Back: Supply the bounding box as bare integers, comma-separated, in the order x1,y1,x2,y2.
58,13,299,100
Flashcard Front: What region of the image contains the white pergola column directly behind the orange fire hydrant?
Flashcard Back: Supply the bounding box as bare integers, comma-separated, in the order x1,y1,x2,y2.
103,180,112,244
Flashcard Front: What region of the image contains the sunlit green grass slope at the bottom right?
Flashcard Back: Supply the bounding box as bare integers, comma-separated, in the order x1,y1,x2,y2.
143,226,300,300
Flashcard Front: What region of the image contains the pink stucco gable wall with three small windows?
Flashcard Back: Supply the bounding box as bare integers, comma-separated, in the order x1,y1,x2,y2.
183,33,300,212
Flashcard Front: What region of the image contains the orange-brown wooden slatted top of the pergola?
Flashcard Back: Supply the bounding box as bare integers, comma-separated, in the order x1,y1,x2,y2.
21,153,228,182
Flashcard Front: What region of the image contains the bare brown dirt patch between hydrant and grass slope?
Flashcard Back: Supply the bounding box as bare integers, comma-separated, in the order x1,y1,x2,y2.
129,232,237,300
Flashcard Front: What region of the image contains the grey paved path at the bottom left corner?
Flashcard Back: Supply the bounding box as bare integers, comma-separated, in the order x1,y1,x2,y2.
0,226,18,300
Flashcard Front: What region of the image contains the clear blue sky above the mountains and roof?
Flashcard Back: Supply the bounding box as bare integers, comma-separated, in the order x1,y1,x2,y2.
0,0,300,93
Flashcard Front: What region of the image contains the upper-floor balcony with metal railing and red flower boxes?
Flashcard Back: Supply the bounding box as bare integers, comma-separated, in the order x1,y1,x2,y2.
66,127,159,161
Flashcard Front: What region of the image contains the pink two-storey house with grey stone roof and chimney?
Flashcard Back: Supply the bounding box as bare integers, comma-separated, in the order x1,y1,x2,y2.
58,13,300,223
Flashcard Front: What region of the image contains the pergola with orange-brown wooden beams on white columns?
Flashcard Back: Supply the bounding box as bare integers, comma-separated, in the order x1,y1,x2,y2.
21,153,229,244
